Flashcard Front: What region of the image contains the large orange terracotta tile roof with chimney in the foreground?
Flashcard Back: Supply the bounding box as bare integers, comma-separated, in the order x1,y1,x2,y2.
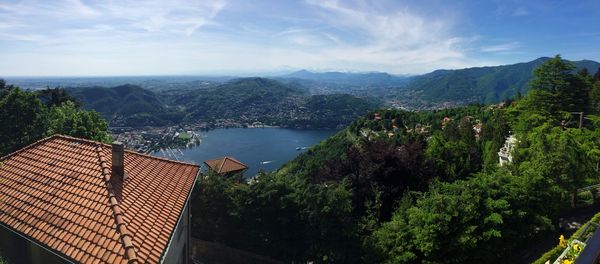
0,136,198,263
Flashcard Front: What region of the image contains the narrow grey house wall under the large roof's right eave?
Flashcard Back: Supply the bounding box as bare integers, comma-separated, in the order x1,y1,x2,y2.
163,200,190,264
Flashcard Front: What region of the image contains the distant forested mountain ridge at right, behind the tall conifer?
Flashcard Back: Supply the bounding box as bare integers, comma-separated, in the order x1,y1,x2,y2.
406,57,600,103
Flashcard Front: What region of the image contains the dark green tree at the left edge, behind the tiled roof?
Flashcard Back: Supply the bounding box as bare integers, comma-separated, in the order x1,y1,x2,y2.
0,88,47,155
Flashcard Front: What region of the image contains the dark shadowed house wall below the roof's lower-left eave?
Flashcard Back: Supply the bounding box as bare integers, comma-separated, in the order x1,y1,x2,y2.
0,225,70,264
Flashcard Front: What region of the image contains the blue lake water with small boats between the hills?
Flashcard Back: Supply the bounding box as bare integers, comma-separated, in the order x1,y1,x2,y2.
154,128,337,177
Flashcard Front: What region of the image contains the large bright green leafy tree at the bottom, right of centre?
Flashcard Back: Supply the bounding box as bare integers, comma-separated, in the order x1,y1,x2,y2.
368,170,557,263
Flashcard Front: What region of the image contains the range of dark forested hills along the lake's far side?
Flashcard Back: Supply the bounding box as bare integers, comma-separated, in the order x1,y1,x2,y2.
68,78,380,128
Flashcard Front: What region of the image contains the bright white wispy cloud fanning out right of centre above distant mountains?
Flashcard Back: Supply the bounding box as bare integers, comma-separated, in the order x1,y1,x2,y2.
298,0,486,73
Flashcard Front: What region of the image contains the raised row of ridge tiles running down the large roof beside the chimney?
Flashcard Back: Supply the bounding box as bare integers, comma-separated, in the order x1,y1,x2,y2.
95,144,139,263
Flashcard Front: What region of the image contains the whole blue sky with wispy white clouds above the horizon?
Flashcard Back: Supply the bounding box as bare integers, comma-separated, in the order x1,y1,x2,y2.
0,0,600,77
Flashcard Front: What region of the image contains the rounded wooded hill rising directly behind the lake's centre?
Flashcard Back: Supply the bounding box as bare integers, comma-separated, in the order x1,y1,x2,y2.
174,78,380,128
